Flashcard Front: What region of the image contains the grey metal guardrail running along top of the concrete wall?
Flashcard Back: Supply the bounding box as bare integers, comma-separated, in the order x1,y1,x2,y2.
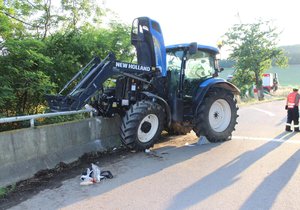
0,109,95,127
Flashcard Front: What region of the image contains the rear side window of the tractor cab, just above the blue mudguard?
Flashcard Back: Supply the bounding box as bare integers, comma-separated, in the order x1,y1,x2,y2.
185,50,215,79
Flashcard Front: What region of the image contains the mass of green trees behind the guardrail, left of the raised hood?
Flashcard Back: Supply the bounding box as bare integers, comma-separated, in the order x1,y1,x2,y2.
0,0,133,116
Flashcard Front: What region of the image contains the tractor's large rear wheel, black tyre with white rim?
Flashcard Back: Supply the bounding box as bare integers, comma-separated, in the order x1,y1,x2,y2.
194,88,238,142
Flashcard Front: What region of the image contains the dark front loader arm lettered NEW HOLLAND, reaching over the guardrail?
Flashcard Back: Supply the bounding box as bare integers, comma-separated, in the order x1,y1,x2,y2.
46,53,157,111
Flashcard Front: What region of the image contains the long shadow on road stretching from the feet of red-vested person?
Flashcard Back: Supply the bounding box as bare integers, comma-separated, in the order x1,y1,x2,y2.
167,132,298,210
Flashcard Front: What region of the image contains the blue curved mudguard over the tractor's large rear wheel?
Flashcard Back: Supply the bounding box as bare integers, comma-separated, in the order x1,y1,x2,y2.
193,78,240,113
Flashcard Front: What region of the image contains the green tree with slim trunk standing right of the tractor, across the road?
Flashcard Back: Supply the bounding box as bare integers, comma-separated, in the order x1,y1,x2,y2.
224,20,288,100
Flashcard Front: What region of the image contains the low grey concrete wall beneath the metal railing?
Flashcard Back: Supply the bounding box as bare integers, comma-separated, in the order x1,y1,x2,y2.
0,117,121,187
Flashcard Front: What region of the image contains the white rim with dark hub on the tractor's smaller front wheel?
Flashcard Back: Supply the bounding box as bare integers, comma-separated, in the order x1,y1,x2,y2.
138,114,159,143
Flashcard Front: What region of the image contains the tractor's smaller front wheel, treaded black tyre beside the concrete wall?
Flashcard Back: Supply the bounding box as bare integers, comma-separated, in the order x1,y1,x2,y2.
121,101,165,151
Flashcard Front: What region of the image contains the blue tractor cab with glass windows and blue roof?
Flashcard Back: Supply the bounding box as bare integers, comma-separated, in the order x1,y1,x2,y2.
166,43,220,121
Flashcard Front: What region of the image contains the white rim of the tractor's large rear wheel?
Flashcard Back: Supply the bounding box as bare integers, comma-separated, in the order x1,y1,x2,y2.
209,99,231,132
